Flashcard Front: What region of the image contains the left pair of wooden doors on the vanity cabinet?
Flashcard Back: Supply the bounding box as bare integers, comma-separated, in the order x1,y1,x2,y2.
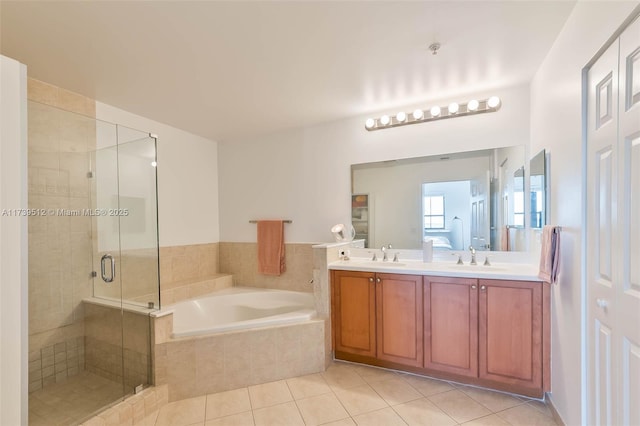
333,271,423,367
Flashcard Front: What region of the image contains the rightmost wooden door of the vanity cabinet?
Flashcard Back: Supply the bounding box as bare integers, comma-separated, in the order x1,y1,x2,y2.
478,280,543,389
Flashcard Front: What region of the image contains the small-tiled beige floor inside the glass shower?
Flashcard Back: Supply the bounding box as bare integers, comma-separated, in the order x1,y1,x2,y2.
29,371,123,426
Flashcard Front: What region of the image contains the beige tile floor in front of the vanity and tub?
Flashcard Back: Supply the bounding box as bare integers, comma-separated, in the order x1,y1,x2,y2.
145,362,556,426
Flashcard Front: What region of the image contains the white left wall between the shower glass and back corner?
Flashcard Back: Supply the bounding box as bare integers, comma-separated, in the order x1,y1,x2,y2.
96,102,220,247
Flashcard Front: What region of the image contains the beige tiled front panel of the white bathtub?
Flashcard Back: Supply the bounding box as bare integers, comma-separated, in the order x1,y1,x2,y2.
154,316,327,401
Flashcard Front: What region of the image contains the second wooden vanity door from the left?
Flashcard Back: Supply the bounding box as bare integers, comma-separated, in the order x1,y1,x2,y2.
376,274,423,367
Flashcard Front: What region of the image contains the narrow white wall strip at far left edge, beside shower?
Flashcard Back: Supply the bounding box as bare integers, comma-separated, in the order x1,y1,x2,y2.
0,56,29,425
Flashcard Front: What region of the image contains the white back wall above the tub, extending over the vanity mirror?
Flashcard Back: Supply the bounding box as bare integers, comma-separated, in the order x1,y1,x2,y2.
219,85,529,242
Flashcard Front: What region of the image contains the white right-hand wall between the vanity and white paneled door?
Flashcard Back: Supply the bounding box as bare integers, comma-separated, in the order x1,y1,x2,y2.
530,1,638,425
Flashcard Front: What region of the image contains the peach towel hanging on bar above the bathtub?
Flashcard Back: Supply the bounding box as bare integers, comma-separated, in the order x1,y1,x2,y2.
258,220,285,275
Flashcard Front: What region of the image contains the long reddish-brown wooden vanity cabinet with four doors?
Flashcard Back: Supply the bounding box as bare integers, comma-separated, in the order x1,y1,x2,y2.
332,270,550,397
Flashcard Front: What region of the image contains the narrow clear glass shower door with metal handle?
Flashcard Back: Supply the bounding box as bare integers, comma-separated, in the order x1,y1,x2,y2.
84,121,127,416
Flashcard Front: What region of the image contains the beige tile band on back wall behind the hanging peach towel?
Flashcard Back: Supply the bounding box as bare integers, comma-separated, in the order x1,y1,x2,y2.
220,242,313,292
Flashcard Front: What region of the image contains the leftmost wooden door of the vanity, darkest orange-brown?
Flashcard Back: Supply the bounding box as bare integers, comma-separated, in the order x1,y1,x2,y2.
332,271,376,357
